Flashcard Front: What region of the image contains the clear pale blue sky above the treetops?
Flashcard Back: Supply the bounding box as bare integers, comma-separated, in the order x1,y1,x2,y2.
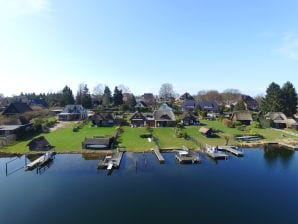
0,0,298,96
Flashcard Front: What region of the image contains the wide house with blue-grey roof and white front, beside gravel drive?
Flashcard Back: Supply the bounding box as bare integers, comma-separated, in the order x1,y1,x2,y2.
58,105,87,121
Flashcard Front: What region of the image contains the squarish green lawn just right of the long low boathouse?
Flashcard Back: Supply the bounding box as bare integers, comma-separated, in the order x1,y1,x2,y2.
118,126,155,152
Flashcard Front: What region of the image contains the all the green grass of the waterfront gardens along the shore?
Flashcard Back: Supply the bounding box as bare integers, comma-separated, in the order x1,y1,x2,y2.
0,120,298,153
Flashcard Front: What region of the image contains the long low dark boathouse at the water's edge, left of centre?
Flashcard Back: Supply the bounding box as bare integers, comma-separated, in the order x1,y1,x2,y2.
82,136,114,149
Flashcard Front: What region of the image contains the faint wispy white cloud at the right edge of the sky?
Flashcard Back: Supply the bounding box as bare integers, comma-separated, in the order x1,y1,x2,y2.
277,33,298,60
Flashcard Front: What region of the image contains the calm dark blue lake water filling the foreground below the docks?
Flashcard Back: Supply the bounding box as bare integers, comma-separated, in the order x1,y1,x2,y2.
0,149,298,224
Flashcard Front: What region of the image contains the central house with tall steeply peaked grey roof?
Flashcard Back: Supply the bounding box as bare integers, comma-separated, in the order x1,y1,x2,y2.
153,103,176,127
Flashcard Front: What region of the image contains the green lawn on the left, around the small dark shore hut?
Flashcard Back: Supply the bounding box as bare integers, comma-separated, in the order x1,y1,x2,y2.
1,122,115,153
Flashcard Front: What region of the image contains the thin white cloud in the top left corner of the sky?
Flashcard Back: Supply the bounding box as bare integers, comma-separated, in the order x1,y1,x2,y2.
0,0,51,17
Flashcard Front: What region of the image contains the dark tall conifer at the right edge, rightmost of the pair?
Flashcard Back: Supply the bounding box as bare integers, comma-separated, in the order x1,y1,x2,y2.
281,81,297,116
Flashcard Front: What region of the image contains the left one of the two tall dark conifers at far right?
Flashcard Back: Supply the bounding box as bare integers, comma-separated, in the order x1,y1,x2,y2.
261,82,283,113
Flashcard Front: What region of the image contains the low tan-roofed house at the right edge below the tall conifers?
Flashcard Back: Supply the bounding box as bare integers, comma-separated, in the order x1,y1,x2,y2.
265,112,297,129
